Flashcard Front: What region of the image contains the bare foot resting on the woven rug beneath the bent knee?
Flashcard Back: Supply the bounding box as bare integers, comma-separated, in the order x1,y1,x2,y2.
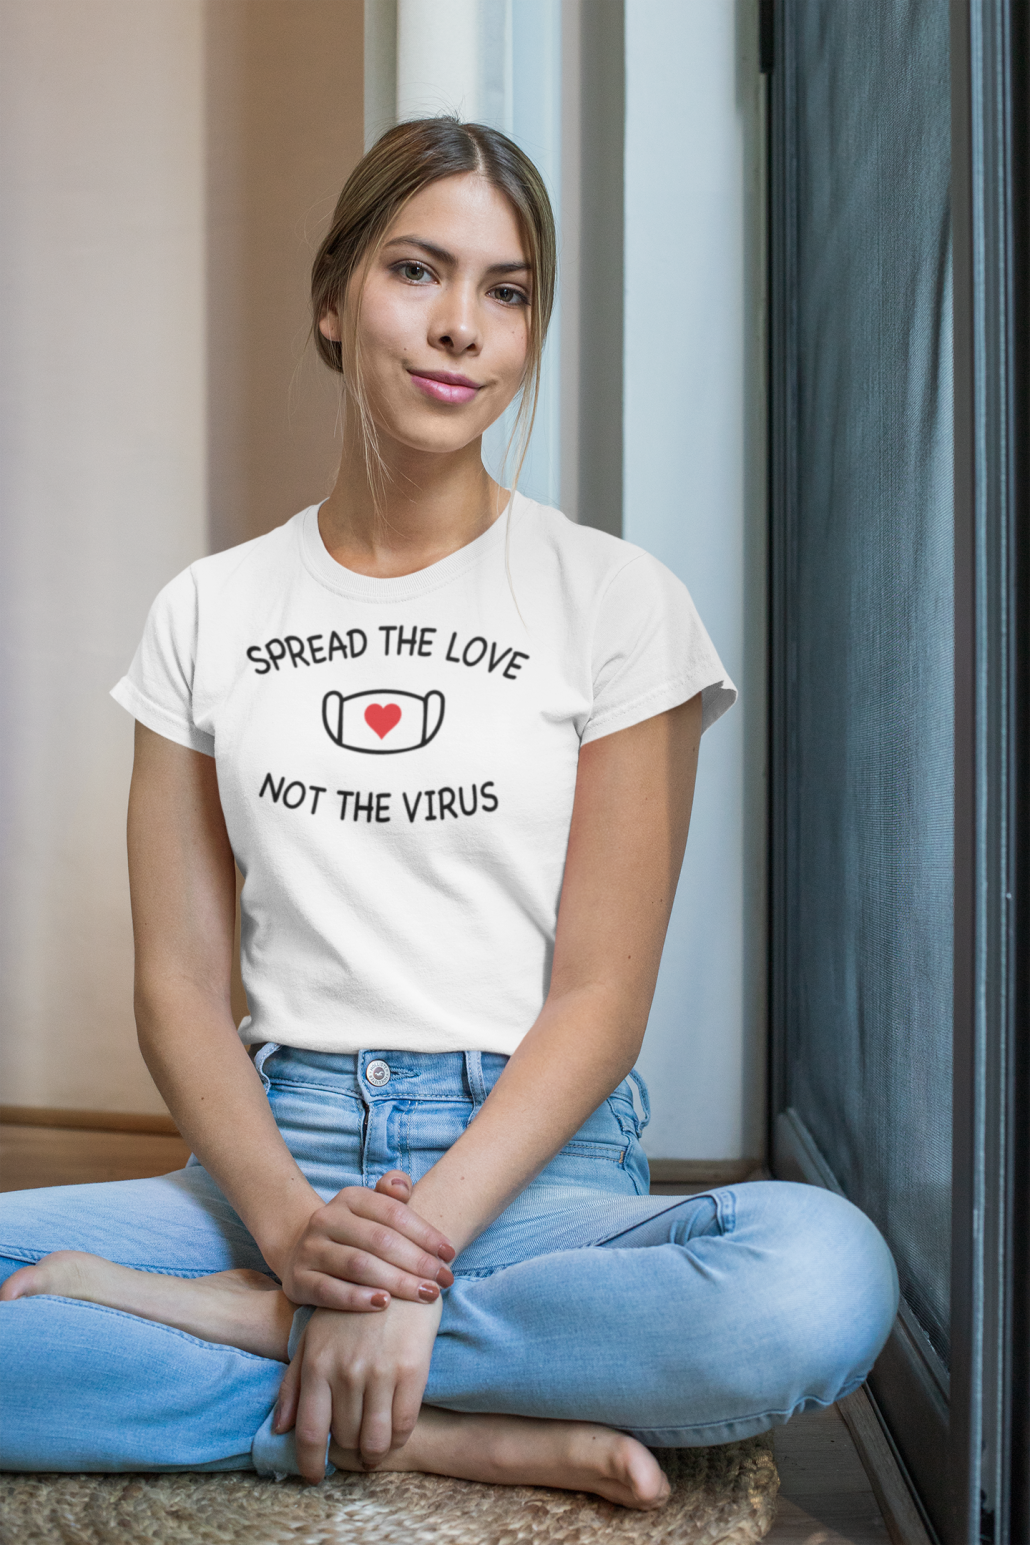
329,1406,670,1509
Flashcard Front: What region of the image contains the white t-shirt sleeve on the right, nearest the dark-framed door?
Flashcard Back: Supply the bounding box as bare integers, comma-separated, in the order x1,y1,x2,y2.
582,553,737,745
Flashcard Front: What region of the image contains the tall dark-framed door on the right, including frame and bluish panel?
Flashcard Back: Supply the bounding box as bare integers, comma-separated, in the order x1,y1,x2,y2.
769,0,1030,1545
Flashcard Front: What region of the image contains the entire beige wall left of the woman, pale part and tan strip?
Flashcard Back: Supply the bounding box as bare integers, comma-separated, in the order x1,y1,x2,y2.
0,0,363,1112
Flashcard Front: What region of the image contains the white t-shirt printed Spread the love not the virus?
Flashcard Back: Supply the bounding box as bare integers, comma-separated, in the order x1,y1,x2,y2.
113,494,737,1054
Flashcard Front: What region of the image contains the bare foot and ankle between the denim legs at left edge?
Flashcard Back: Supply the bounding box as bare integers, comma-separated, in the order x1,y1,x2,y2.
0,1250,295,1363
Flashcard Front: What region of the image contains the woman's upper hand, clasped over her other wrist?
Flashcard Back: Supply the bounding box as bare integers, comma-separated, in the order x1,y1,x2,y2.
280,1170,454,1313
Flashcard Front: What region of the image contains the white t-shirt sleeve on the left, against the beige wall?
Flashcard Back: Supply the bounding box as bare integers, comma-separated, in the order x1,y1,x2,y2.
111,569,215,757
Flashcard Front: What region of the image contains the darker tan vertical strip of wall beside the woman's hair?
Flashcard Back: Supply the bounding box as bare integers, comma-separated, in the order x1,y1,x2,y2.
207,0,364,550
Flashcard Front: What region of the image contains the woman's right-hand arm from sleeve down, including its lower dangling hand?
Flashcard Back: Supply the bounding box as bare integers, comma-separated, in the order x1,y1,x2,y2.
275,697,701,1480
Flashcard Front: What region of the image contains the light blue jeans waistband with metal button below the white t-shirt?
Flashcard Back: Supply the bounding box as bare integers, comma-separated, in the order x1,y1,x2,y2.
253,1041,508,1109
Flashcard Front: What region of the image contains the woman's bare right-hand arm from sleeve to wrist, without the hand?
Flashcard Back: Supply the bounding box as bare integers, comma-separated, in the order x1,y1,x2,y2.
411,695,701,1251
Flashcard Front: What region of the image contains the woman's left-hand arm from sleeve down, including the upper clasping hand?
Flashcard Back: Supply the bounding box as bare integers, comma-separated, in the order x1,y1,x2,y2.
128,723,452,1310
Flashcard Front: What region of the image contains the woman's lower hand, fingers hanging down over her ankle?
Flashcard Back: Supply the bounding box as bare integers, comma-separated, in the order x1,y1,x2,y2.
272,1299,443,1482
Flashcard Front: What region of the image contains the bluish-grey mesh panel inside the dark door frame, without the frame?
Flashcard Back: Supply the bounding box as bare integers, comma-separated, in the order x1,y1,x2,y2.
774,0,954,1364
